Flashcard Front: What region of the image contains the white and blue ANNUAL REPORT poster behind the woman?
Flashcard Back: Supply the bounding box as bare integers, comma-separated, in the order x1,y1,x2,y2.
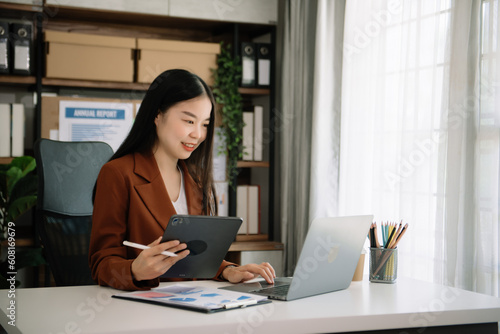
59,100,134,152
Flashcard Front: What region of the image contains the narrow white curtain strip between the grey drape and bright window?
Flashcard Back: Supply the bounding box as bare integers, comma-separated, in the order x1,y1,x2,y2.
309,0,345,221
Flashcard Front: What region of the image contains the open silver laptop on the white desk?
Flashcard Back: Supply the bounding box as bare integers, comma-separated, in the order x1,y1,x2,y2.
221,215,373,300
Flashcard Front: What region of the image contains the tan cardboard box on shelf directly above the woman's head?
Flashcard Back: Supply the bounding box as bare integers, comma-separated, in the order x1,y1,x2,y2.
137,38,220,85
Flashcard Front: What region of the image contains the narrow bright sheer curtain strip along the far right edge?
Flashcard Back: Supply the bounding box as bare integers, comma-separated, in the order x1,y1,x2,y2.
474,0,500,296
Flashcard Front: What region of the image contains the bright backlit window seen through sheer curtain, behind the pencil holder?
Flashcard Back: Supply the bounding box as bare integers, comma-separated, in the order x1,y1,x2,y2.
340,0,452,281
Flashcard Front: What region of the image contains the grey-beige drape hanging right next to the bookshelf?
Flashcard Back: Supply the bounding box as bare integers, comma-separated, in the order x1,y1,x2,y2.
277,0,316,275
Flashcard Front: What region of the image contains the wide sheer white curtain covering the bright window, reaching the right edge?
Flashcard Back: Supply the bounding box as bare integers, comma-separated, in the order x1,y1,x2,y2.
339,0,499,295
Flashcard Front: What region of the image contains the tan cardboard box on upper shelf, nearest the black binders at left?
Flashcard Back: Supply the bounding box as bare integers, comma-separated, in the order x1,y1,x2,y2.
45,30,136,82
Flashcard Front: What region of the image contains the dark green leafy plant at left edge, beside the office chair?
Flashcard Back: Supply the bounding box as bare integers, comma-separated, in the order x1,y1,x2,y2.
0,156,45,289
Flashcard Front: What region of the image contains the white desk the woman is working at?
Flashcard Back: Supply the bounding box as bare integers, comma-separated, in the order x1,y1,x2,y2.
0,279,500,334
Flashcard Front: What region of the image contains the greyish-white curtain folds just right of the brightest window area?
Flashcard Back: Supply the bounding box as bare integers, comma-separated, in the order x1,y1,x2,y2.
434,0,481,290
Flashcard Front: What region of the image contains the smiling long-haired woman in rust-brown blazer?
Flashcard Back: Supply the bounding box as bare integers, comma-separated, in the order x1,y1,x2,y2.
89,70,275,290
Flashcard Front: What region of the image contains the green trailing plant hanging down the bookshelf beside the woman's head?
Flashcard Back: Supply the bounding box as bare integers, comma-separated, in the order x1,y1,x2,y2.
212,42,244,188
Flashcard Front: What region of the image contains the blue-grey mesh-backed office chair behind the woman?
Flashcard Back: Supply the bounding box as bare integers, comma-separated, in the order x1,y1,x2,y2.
34,139,113,286
